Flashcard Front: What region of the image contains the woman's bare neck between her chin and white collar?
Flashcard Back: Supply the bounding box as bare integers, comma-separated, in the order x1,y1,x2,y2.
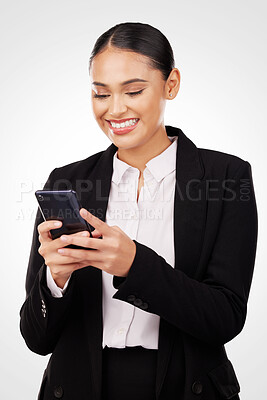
117,127,172,172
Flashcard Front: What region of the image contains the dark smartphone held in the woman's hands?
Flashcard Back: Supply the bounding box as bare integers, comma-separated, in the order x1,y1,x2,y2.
35,190,93,249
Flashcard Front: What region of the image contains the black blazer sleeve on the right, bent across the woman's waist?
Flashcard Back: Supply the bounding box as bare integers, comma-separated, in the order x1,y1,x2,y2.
113,161,258,345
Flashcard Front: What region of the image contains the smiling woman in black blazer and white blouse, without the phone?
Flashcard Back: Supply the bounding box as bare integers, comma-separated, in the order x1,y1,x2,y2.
21,23,257,400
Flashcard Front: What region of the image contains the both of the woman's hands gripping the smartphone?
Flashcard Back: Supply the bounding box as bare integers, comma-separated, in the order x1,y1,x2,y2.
38,208,136,287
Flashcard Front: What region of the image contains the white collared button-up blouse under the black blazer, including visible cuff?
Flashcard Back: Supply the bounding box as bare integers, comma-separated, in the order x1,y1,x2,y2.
47,136,178,349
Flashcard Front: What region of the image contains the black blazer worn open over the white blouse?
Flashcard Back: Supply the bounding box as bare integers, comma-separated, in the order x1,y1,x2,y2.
20,126,258,400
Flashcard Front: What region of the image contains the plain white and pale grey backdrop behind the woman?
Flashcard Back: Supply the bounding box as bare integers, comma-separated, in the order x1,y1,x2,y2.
0,0,267,400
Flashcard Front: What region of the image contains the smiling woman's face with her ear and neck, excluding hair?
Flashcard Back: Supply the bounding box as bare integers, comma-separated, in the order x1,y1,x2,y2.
90,50,180,170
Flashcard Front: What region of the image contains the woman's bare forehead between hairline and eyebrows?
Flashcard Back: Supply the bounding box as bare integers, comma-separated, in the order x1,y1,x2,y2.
90,48,161,84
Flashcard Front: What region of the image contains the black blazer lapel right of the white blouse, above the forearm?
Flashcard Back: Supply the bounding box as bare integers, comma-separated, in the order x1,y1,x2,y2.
171,128,207,278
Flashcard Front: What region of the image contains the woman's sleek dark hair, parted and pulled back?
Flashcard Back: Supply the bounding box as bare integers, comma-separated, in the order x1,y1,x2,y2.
89,22,174,80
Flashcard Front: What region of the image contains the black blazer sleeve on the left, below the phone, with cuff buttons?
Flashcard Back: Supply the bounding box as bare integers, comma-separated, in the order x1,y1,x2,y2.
20,170,75,355
